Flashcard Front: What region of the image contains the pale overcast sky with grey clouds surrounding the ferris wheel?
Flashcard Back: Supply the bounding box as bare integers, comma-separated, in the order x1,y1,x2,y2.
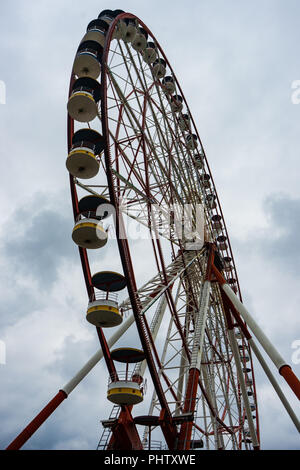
0,0,300,449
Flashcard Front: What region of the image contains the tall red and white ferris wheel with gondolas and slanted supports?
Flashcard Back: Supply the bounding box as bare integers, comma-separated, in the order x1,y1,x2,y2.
9,10,299,450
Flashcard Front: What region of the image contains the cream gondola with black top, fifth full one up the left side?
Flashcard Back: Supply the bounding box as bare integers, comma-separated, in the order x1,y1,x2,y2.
68,77,101,122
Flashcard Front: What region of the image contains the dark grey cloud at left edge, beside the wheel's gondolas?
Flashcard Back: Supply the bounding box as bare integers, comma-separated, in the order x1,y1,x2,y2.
1,191,76,289
